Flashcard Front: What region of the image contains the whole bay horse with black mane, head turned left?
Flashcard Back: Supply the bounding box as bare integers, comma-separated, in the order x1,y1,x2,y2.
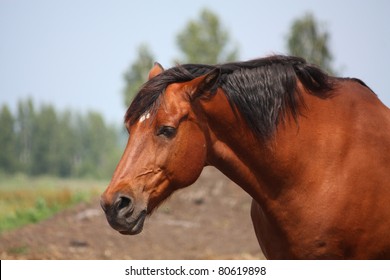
101,55,390,259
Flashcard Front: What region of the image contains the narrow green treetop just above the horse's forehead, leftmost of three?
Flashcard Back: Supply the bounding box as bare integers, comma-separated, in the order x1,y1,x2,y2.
123,44,155,108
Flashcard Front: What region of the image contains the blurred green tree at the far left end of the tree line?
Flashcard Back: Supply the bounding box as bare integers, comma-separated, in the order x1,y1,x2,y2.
0,105,17,173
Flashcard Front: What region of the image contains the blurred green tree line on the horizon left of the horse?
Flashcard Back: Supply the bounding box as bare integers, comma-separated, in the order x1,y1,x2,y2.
0,98,121,178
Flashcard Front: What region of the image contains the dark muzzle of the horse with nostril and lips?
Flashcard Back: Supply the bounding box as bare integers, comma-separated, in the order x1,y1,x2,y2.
100,195,147,235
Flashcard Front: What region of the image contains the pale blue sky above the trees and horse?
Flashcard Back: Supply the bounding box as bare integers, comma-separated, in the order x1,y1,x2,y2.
0,0,390,125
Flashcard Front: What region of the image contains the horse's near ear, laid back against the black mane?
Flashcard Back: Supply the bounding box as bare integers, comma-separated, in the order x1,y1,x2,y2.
190,68,221,100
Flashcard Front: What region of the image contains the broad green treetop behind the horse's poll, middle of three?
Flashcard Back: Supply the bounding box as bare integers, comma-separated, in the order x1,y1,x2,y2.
176,9,238,64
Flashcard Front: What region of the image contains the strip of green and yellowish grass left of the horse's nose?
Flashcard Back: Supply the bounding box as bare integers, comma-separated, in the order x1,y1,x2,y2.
0,175,108,233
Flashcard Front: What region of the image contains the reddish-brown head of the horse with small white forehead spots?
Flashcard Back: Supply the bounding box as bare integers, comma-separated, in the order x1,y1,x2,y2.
101,64,219,234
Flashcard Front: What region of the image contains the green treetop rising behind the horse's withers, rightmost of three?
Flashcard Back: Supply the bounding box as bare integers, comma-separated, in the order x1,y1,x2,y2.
287,13,335,74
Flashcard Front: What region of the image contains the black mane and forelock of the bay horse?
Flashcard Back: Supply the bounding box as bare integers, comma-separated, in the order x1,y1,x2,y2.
125,55,333,138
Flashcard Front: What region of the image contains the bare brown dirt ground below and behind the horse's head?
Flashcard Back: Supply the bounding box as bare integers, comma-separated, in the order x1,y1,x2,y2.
0,168,264,260
